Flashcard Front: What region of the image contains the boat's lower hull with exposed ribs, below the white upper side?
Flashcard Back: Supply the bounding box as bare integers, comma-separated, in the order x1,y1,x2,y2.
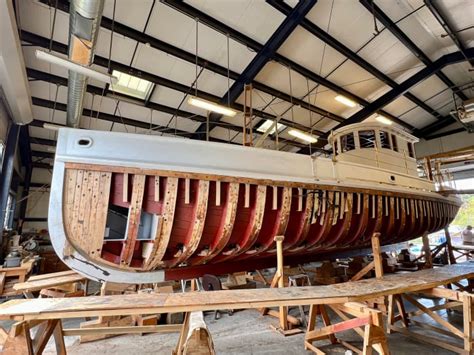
49,130,459,283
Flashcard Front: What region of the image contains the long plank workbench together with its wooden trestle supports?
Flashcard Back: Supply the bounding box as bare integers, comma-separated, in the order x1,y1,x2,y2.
0,262,474,354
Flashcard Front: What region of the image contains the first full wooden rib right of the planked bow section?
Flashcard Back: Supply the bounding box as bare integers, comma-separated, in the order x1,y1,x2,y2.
120,175,146,267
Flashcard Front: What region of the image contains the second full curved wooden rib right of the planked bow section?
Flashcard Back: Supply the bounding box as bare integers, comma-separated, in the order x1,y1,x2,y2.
144,177,178,271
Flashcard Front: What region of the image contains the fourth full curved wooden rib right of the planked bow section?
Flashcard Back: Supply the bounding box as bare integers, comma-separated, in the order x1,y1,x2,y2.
198,182,240,264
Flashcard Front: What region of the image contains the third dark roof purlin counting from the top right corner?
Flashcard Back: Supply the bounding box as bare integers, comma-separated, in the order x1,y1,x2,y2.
267,0,450,124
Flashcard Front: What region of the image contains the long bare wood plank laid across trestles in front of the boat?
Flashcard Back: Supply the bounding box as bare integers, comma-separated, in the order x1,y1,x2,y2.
0,263,474,320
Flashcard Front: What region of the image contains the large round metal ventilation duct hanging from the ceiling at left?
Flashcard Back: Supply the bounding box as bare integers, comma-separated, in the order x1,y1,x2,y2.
67,0,104,127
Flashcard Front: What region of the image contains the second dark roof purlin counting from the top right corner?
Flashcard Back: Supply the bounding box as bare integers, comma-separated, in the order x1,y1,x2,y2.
359,0,468,100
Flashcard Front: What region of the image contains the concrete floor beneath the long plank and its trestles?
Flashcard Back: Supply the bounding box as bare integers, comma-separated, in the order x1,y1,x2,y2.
25,299,462,355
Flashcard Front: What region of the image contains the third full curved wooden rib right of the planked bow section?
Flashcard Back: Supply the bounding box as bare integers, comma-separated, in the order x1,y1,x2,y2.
164,180,209,268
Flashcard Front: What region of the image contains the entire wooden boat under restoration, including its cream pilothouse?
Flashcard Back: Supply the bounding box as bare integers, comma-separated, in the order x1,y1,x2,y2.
49,123,460,283
